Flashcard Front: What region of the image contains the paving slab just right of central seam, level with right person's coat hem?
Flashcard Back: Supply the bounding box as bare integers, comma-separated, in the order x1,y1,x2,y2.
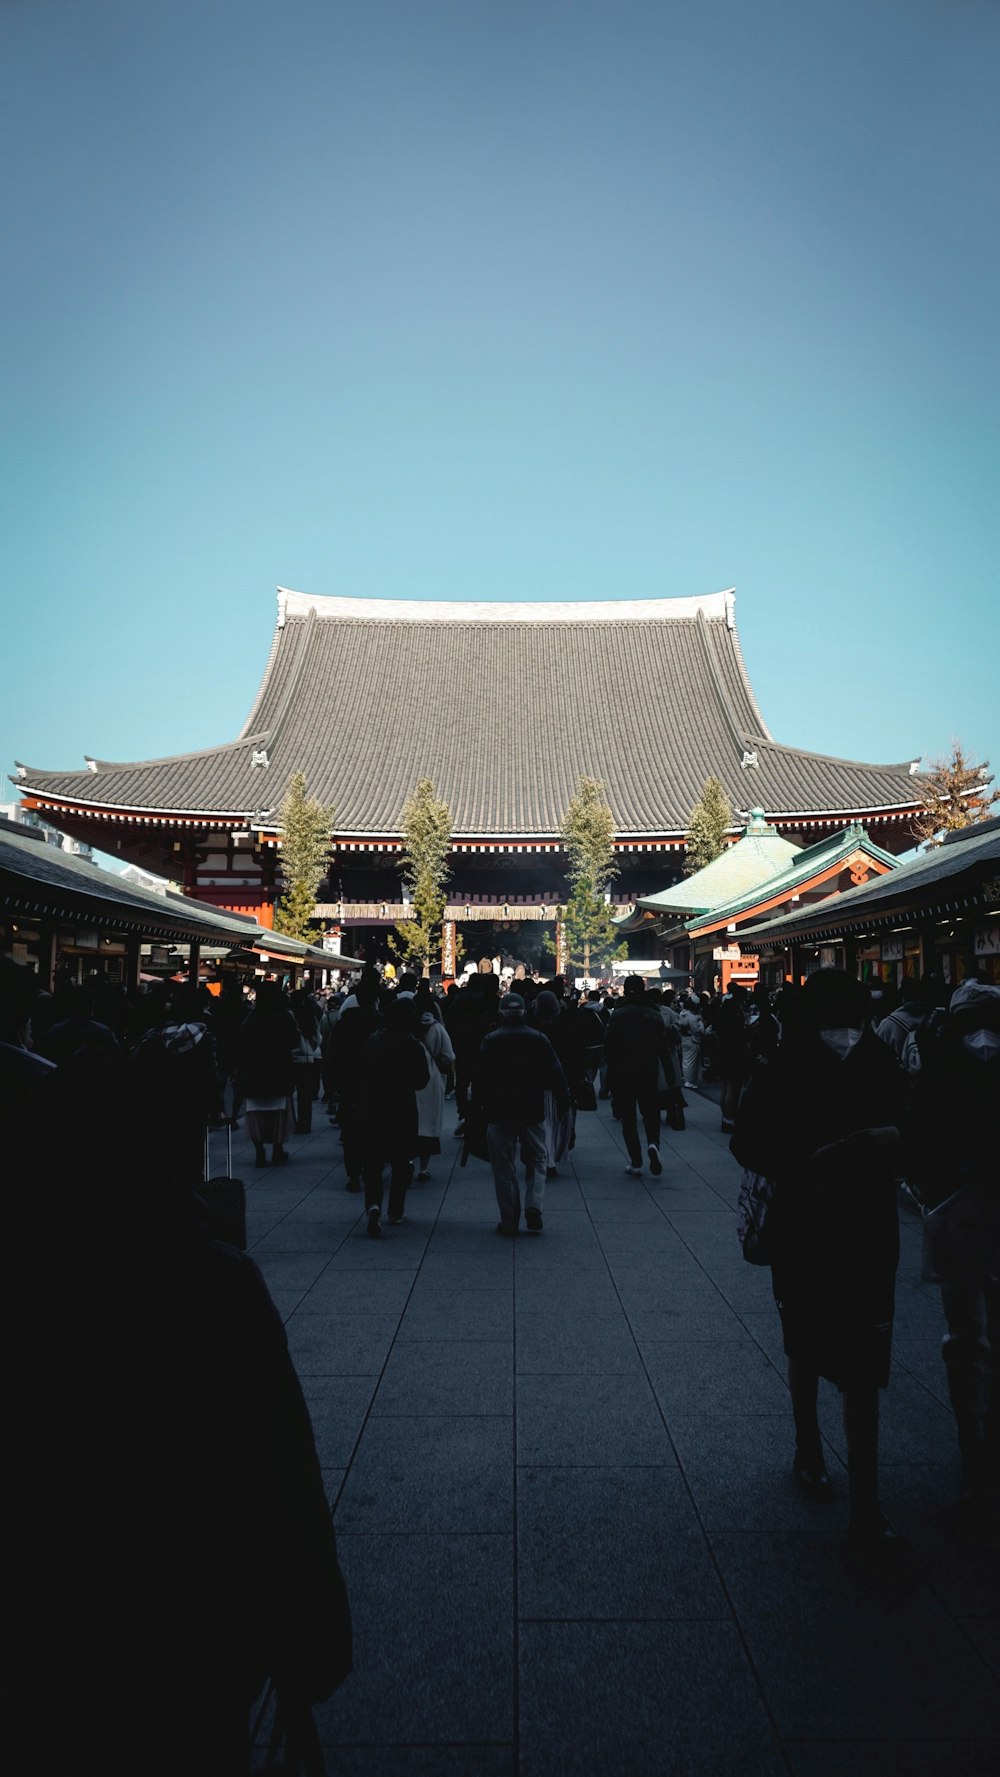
517,1375,673,1468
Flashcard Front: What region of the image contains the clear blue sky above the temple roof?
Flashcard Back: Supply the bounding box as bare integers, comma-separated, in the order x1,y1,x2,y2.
0,0,1000,813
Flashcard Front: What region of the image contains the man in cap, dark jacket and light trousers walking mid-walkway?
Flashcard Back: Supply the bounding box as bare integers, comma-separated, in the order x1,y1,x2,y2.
472,993,570,1235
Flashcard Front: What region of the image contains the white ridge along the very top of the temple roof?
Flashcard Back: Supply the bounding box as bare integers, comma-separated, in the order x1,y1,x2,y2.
277,586,735,629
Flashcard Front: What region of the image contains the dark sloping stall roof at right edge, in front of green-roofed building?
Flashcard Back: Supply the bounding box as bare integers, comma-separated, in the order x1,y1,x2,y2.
741,817,1000,949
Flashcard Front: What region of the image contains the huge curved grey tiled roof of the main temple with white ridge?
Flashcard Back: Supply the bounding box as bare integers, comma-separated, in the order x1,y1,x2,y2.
20,592,920,839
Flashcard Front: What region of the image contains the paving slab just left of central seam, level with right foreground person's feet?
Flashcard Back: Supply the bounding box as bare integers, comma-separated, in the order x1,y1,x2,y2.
337,1416,513,1534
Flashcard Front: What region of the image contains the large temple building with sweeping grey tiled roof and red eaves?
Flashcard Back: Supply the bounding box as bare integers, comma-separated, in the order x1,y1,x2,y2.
16,588,920,954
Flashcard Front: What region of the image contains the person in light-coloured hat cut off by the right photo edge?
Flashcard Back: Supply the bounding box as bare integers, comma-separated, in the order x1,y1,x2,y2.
909,981,1000,1546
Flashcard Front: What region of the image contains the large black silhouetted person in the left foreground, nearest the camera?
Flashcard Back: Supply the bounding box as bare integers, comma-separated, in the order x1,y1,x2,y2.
2,1052,352,1777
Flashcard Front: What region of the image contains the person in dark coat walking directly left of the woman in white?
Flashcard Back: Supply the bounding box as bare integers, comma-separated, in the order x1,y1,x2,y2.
362,995,430,1240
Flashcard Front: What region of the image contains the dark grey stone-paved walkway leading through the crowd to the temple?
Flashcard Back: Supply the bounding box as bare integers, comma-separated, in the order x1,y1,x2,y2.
243,1093,1000,1777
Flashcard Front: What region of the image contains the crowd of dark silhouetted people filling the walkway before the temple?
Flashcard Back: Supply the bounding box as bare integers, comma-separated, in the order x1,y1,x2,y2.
0,963,1000,1755
